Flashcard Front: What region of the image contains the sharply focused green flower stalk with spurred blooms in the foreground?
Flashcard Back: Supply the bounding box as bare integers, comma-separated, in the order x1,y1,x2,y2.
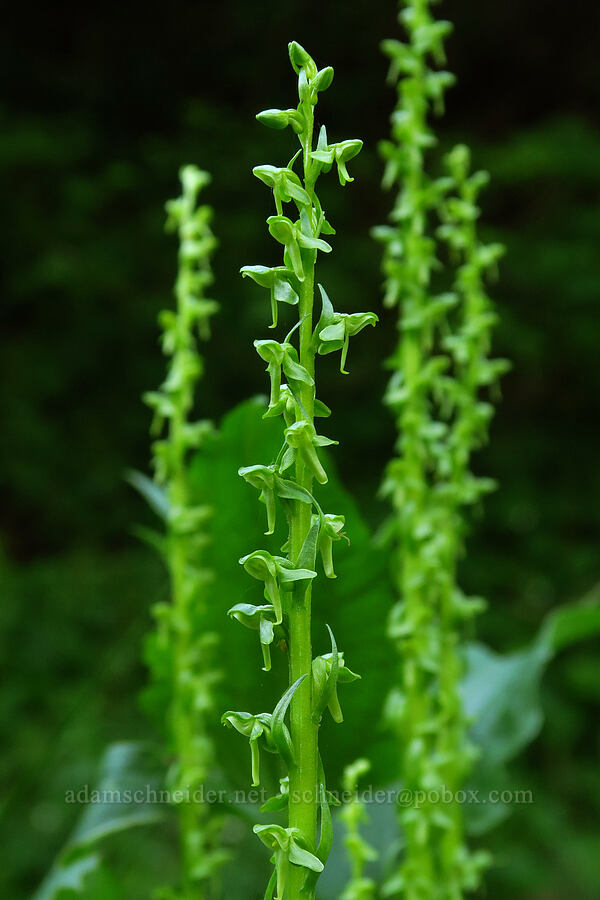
223,42,377,900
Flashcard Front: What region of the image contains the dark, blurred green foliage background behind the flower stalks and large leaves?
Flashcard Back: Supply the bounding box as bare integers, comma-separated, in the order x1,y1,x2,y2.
0,0,600,900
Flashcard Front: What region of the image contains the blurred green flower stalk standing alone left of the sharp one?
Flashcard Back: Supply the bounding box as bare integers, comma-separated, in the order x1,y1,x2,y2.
137,166,225,900
